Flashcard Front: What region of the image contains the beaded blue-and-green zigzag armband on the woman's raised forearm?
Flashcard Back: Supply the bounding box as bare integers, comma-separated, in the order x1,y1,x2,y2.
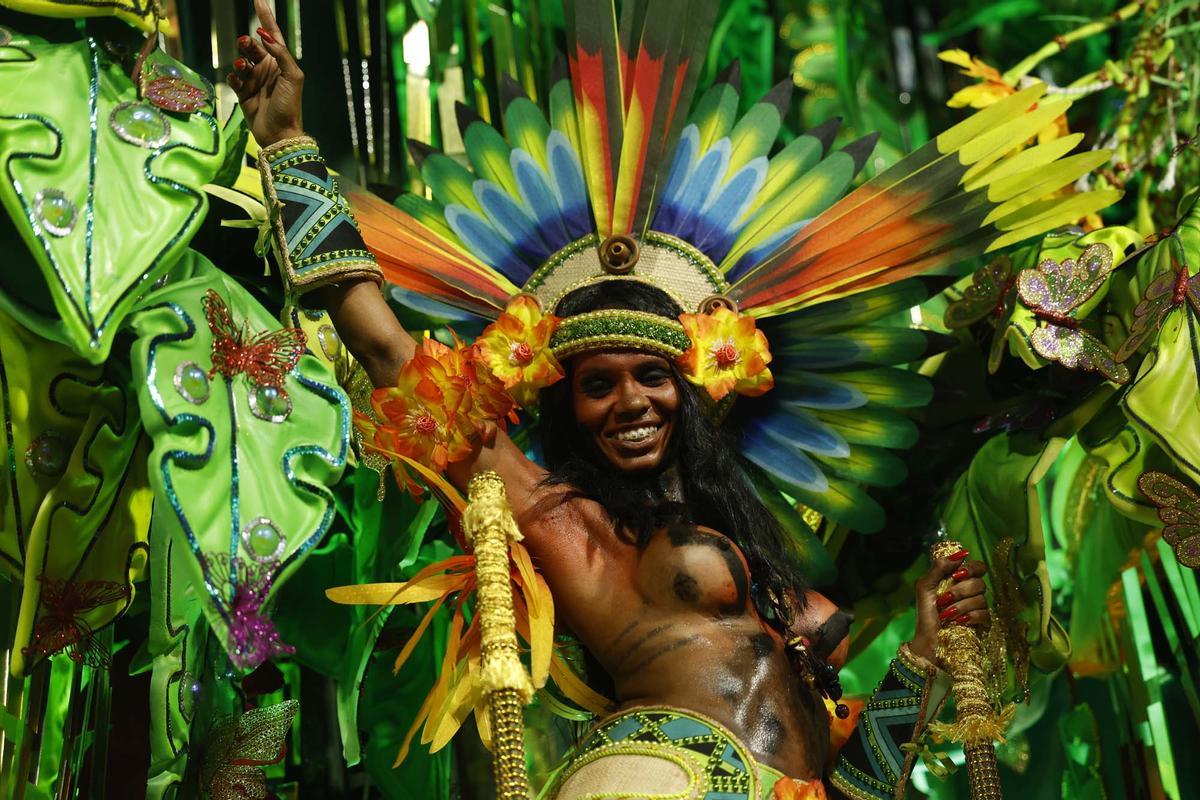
258,137,383,295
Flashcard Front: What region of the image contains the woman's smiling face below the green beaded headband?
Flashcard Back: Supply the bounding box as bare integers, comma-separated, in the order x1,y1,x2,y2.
571,351,679,473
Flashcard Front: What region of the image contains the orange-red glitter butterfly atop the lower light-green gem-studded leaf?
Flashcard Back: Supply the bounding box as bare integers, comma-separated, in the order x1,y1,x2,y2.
203,289,307,393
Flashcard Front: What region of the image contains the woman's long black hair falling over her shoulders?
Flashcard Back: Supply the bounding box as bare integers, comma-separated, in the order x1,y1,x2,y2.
539,281,808,630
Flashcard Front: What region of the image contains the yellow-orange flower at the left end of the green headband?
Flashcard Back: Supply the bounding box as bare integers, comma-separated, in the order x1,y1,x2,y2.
475,295,563,407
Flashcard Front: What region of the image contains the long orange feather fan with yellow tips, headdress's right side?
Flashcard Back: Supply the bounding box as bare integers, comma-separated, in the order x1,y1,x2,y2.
731,84,1120,317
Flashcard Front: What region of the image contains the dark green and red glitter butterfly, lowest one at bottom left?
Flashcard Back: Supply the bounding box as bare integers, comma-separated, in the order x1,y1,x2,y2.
200,700,300,800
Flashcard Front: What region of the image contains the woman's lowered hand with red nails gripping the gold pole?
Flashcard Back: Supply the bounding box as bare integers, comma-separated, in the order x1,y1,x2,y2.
908,551,991,661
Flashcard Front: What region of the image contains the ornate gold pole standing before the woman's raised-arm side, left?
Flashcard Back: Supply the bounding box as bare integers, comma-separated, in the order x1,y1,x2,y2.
462,471,533,800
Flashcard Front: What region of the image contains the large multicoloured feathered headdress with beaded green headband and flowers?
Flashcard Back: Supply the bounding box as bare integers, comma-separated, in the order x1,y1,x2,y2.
352,0,1118,544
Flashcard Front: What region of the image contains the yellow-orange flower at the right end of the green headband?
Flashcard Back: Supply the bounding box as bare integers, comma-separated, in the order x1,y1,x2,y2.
678,308,775,402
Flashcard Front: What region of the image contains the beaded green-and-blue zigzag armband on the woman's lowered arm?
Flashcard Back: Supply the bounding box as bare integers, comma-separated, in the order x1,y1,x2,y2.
829,648,936,800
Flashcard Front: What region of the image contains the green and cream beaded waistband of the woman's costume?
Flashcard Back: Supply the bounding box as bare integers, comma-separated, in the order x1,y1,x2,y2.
553,706,826,800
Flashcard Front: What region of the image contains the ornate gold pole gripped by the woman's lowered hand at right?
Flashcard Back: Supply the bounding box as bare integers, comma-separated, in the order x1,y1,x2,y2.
929,541,1016,800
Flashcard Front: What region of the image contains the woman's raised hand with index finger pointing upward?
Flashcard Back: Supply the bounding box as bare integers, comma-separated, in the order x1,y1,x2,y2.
226,0,304,148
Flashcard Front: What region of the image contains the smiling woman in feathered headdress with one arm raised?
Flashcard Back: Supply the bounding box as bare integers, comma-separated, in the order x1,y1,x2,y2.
229,0,1113,800
